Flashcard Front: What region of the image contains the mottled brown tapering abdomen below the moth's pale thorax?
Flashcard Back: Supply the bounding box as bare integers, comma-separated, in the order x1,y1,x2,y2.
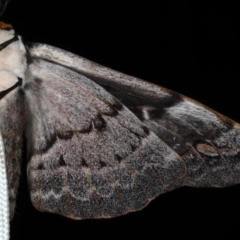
0,87,25,219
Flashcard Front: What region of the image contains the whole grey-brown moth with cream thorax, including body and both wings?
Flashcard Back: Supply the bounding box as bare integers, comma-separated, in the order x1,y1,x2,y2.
0,0,239,229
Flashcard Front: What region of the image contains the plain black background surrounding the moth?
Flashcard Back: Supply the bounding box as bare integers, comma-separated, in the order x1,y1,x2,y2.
2,0,240,240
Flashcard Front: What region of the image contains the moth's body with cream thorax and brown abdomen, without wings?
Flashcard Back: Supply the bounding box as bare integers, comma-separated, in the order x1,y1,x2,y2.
0,24,27,218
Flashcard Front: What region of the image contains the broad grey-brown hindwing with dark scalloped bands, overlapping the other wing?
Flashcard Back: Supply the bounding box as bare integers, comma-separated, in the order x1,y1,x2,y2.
24,58,186,219
